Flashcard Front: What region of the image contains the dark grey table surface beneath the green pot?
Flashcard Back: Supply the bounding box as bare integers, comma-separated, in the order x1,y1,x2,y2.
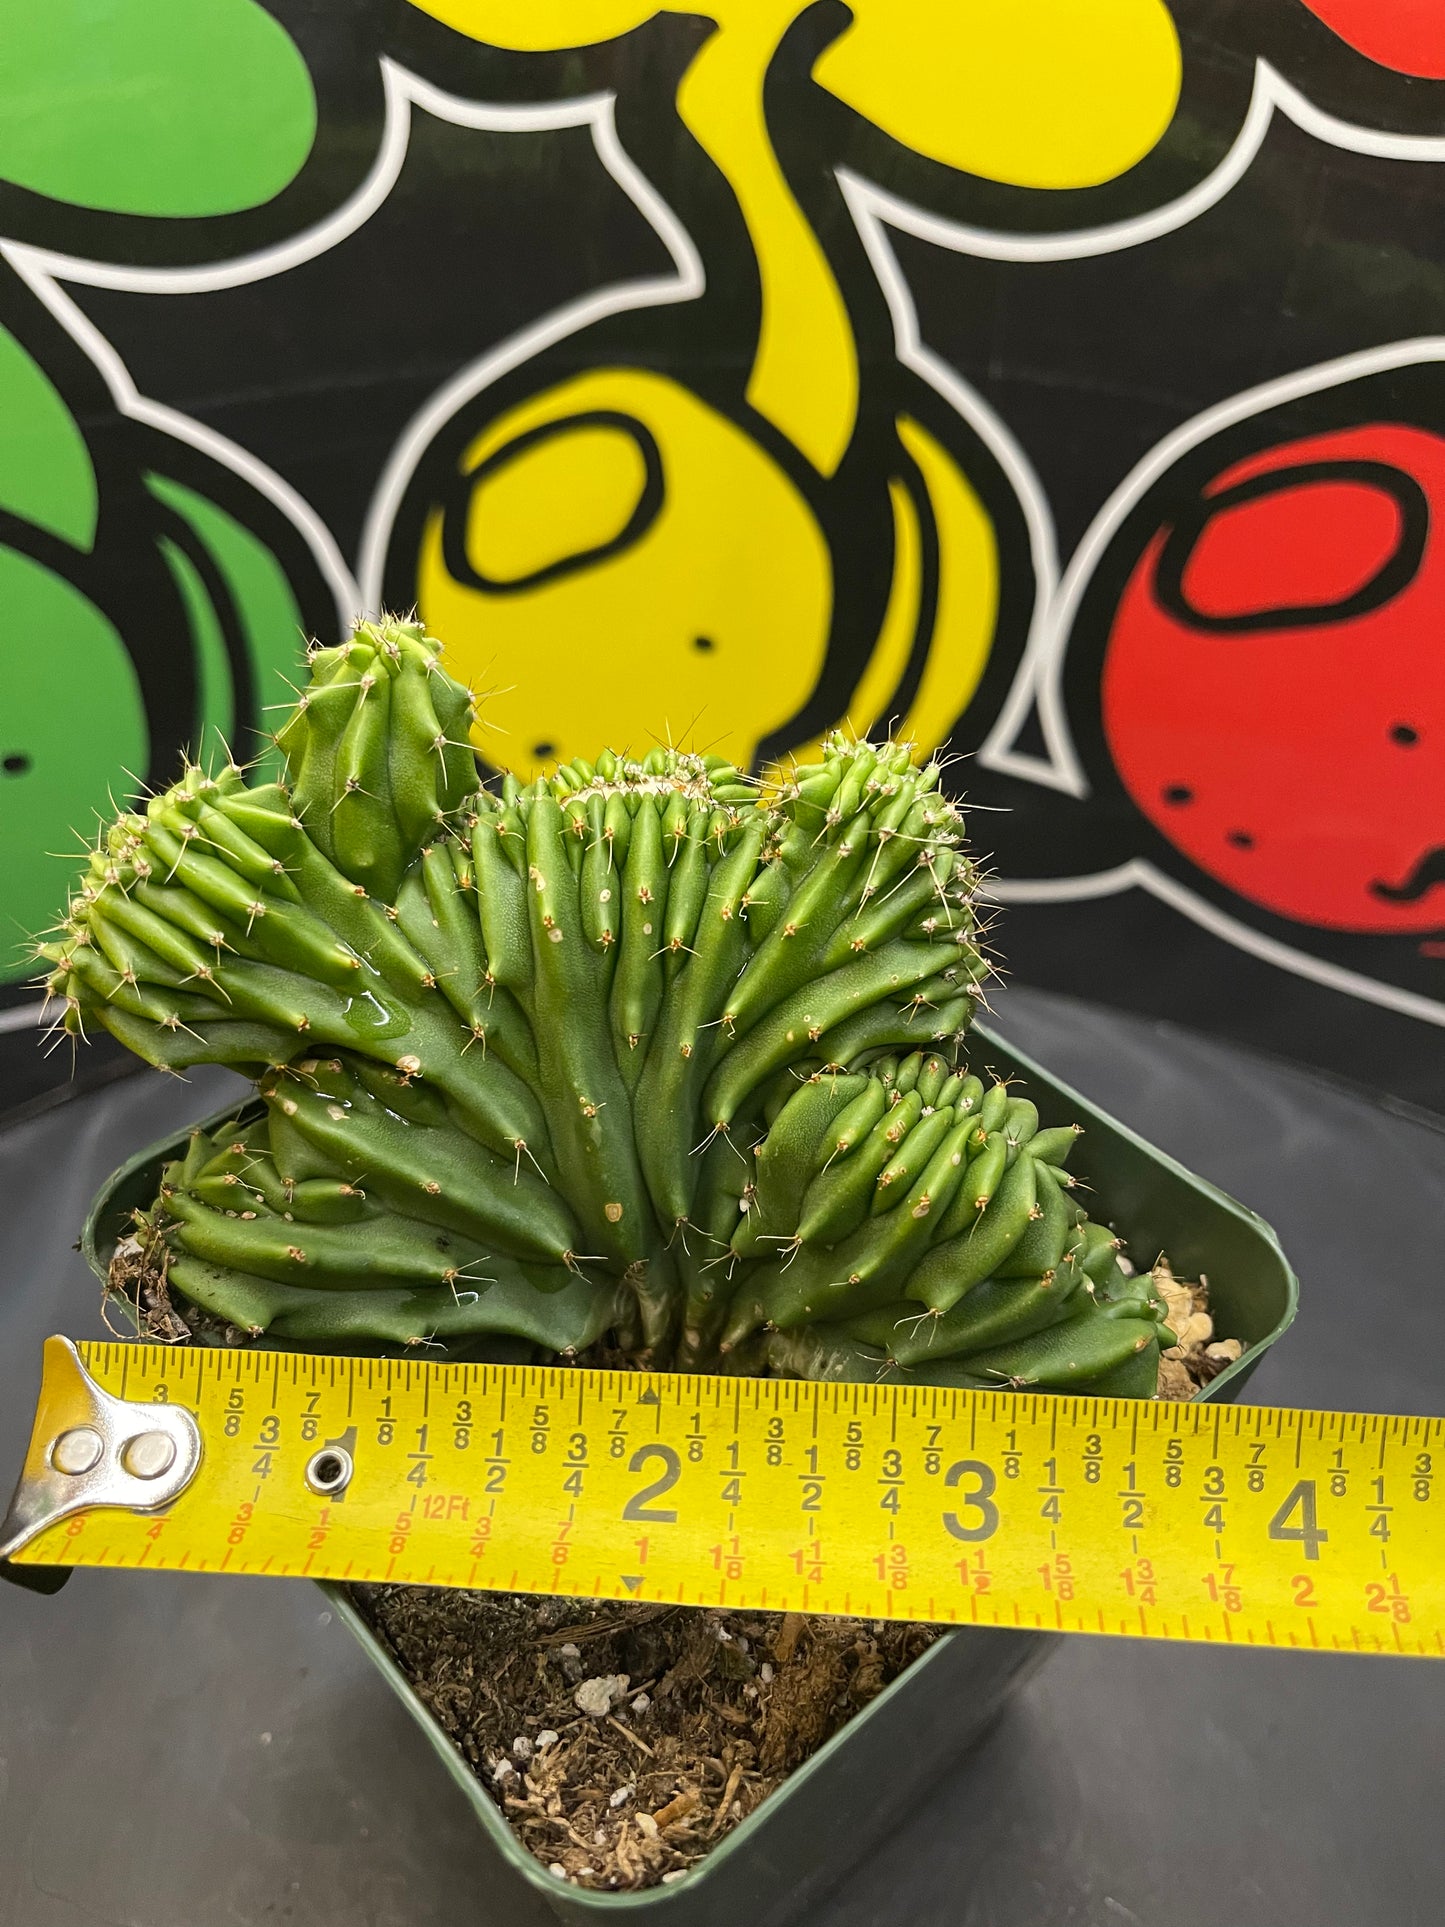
0,990,1445,1927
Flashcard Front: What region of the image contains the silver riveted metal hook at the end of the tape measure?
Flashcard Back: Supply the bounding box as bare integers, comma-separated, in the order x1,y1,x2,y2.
0,1337,202,1559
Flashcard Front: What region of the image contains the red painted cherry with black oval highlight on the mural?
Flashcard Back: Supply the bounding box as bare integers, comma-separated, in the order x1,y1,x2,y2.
1102,422,1445,935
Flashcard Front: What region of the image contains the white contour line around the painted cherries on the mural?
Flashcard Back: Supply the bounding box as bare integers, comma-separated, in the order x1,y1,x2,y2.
0,45,1445,1025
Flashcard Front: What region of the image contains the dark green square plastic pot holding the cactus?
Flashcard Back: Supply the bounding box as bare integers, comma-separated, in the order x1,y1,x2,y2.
81,1025,1299,1927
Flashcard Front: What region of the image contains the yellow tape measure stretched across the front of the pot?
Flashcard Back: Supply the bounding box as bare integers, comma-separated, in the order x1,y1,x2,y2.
0,1339,1445,1657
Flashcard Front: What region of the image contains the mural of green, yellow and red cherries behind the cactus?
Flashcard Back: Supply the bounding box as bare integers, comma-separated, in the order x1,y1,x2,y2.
0,0,1445,1108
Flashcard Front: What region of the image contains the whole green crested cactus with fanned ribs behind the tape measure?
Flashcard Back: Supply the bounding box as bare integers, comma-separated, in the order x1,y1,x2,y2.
44,619,1171,1397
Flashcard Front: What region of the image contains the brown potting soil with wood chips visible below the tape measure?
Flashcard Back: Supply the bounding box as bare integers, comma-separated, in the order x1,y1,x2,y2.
353,1586,944,1892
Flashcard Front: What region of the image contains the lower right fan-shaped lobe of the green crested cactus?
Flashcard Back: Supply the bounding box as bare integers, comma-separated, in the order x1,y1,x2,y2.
723,1054,1169,1393
